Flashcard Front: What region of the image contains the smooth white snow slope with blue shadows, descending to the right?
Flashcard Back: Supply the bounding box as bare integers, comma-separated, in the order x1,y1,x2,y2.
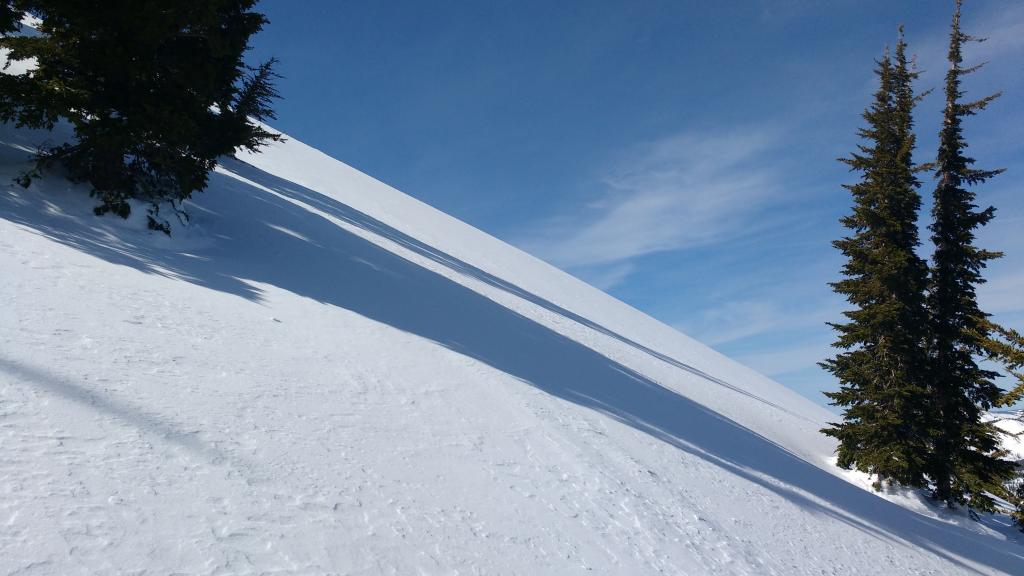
0,121,1024,575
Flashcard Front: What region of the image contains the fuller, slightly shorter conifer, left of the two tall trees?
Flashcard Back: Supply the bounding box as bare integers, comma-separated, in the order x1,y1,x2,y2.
821,29,929,489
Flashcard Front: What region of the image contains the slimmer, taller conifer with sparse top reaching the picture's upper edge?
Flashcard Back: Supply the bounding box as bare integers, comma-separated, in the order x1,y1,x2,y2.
928,0,1016,510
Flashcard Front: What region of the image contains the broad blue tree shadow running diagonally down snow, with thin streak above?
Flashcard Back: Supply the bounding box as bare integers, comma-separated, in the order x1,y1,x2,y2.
0,142,1024,573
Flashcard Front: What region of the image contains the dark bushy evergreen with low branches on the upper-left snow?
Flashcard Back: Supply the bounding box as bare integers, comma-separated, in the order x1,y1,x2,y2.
0,0,280,232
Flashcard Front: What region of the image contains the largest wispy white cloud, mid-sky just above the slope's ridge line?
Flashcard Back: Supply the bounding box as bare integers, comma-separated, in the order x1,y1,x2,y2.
523,130,779,272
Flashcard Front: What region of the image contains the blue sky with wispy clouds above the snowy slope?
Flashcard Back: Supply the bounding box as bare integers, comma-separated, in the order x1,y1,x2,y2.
247,0,1024,403
